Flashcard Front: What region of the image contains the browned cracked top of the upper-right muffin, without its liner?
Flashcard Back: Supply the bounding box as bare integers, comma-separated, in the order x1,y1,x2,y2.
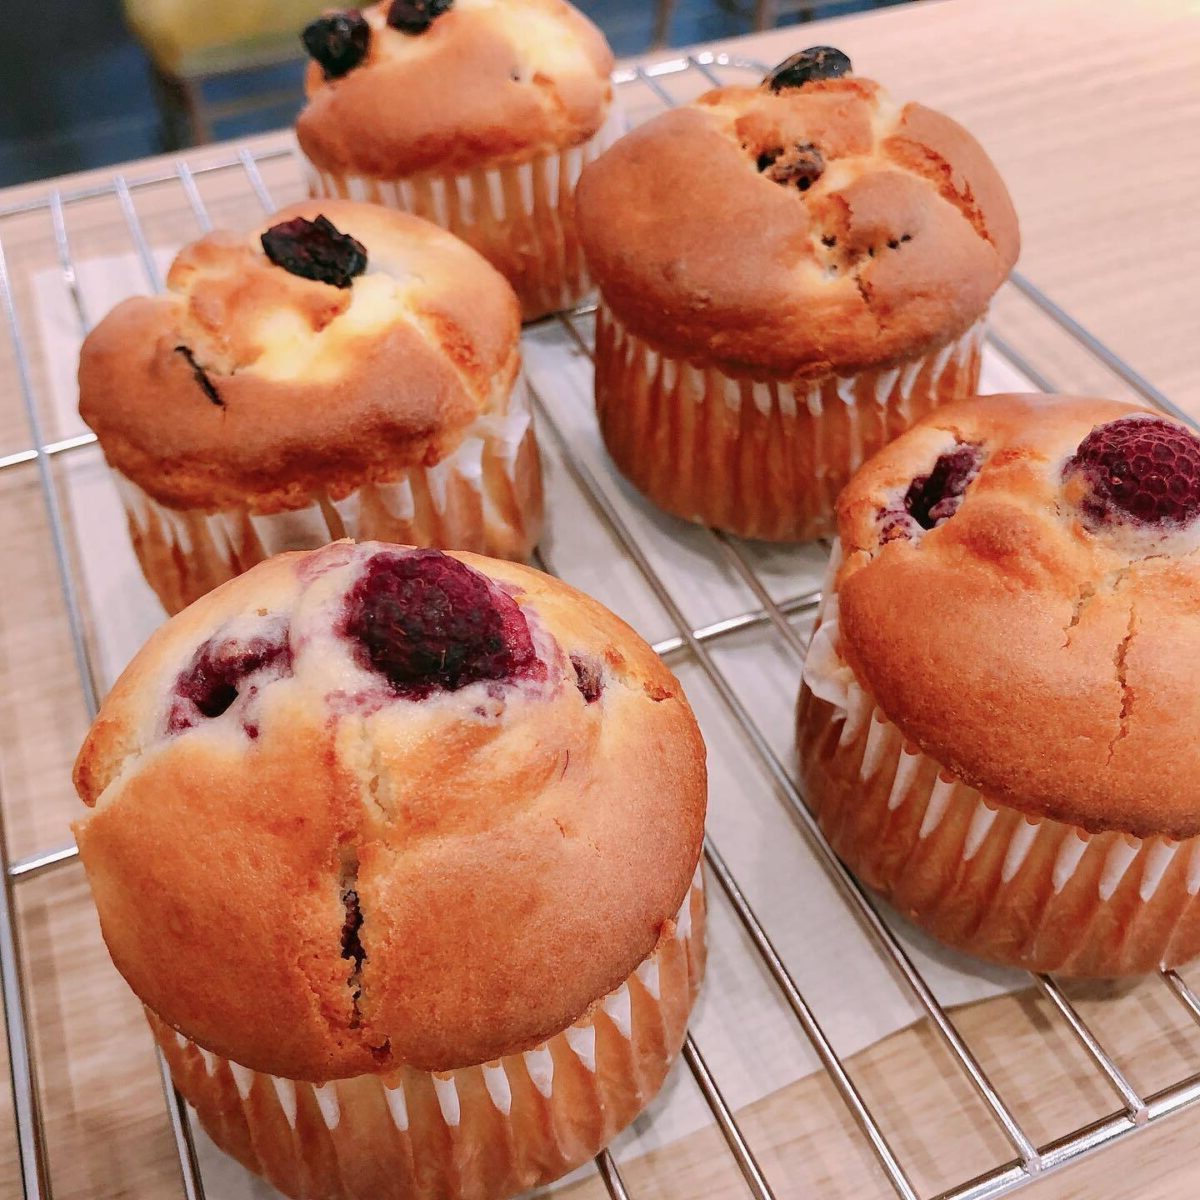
576,47,1019,378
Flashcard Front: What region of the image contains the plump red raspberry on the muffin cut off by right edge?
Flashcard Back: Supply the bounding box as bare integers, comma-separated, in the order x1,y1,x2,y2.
1063,415,1200,526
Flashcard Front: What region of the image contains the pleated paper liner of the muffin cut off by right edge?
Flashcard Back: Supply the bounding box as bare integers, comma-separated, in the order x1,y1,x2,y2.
798,561,1200,977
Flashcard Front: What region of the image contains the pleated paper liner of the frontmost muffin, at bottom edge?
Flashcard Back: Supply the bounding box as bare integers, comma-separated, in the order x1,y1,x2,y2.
146,866,704,1200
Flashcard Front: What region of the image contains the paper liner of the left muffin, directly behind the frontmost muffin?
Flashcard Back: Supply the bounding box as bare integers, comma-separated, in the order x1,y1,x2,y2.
113,377,542,613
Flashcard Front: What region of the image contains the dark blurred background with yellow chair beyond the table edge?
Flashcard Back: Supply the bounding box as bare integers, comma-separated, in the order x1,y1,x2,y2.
0,0,902,187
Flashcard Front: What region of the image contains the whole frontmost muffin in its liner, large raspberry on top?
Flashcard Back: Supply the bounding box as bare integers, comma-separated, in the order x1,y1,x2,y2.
76,541,706,1200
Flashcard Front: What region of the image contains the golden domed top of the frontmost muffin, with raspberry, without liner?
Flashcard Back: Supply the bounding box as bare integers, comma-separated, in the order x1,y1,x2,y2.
76,541,706,1082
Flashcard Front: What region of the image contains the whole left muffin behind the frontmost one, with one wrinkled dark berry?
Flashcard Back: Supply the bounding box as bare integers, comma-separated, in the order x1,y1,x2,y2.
79,200,542,613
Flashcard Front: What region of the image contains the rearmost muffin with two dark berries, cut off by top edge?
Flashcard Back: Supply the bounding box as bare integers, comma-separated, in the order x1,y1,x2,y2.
296,0,619,319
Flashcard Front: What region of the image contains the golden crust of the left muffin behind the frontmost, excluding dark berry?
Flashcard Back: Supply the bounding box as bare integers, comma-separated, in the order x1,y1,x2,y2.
79,199,521,512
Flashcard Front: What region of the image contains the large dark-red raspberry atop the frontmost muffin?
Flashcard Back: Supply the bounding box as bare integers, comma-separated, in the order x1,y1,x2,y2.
343,550,540,700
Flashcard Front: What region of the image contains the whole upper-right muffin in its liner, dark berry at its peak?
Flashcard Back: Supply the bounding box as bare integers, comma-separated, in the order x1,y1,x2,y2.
577,47,1019,541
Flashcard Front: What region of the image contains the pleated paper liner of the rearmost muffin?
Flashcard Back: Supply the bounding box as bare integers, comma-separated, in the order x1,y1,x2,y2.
301,103,625,320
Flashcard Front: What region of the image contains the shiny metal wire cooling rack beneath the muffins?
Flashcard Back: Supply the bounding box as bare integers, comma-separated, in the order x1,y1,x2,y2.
0,54,1200,1200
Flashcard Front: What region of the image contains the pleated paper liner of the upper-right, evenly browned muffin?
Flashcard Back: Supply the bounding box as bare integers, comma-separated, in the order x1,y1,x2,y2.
595,298,984,541
